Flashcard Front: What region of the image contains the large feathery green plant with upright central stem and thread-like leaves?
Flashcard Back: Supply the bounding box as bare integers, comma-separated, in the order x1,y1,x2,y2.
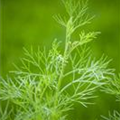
0,0,117,120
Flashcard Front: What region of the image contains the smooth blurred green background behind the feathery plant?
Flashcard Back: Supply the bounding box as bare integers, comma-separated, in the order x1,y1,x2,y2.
0,0,120,120
